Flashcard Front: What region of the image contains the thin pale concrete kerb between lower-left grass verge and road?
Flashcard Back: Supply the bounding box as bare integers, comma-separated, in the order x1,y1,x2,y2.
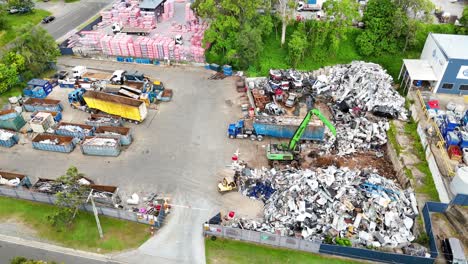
0,234,124,264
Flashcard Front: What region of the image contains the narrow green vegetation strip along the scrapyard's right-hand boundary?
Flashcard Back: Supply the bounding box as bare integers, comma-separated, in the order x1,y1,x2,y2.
405,119,439,201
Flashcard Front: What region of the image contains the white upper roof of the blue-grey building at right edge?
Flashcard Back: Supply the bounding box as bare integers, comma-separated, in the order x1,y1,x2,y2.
431,33,468,60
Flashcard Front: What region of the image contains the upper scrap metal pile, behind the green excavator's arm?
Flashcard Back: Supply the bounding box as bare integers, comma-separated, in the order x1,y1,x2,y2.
308,61,407,155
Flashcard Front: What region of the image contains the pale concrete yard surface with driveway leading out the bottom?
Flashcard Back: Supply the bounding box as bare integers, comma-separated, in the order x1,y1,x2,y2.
0,57,250,264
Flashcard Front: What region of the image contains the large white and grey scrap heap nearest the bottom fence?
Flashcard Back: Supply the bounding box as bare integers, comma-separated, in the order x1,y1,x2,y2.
228,166,418,250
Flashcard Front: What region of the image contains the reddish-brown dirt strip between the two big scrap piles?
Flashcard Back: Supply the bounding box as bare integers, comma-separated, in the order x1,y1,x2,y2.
303,151,395,179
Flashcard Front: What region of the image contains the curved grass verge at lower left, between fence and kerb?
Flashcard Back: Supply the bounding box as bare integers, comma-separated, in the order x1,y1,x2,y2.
0,197,149,253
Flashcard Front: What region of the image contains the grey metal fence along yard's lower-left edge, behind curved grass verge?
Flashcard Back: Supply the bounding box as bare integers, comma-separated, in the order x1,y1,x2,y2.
0,186,165,227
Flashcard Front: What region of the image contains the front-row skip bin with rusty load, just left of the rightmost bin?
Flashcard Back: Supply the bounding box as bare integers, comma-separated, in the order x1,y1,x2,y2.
32,134,75,153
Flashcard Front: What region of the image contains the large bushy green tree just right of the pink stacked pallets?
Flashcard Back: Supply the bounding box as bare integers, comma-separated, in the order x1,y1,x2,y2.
192,0,273,67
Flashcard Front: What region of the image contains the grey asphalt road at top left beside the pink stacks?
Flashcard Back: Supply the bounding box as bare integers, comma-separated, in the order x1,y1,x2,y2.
36,0,112,40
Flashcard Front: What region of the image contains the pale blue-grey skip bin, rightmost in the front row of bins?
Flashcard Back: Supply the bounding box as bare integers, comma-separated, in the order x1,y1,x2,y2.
80,136,120,157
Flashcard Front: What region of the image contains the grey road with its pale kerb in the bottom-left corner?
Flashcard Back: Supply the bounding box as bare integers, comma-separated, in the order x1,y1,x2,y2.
0,235,120,264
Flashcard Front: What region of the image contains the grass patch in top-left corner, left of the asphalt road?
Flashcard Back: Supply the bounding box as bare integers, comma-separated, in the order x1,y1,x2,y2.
0,9,51,47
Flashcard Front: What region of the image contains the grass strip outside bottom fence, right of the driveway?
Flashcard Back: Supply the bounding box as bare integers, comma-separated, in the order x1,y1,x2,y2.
205,238,360,264
